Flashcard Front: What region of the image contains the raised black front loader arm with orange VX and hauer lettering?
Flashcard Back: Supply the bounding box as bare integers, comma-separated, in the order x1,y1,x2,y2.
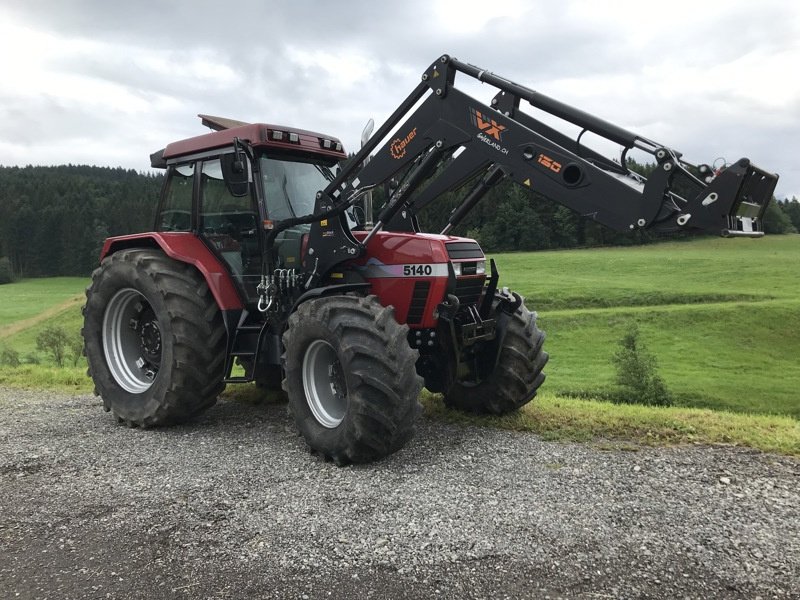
309,55,778,278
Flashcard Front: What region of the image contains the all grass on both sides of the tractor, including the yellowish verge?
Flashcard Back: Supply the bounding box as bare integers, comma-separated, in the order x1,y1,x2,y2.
0,235,800,454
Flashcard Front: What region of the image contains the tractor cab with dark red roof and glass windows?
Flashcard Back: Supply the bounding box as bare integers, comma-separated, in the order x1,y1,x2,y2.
151,115,346,305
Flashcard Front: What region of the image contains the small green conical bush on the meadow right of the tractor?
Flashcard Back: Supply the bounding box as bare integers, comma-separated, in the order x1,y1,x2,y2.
612,324,672,406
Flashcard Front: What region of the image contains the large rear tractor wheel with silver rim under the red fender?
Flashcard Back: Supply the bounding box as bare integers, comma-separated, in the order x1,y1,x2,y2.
81,249,227,427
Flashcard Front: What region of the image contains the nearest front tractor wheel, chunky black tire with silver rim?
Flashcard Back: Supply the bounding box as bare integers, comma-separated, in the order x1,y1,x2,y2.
283,295,422,466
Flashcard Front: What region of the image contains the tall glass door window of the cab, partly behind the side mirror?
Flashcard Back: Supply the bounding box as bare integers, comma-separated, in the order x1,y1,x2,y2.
198,159,261,299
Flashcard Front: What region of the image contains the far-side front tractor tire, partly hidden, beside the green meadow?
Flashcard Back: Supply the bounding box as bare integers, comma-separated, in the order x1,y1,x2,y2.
444,302,549,415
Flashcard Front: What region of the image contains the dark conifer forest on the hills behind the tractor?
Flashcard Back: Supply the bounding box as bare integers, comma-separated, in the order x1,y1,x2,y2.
0,165,800,283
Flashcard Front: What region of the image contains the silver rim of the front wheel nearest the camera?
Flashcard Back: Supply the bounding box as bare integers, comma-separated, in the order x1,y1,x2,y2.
303,340,347,429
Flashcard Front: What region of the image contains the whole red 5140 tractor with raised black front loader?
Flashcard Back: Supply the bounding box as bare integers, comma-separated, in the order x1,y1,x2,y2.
83,56,777,464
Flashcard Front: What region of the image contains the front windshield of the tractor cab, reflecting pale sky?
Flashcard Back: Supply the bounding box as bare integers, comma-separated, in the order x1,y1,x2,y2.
261,156,333,221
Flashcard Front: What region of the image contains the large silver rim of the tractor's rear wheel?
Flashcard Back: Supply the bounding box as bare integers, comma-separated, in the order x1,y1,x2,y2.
103,288,162,394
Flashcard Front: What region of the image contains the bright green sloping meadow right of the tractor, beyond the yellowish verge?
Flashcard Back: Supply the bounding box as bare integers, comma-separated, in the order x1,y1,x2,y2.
496,235,800,418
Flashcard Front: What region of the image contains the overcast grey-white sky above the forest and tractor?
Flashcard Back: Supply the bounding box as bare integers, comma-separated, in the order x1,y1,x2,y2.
0,0,800,199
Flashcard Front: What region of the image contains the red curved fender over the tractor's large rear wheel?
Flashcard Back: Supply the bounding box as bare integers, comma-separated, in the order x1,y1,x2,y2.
100,232,244,312
